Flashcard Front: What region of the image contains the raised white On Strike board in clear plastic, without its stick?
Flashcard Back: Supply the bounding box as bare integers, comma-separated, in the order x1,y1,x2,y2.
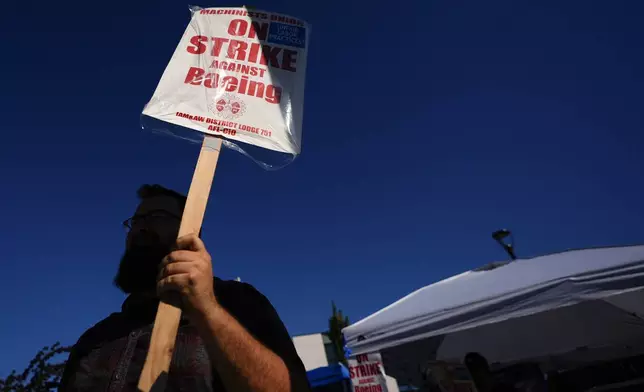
142,7,310,161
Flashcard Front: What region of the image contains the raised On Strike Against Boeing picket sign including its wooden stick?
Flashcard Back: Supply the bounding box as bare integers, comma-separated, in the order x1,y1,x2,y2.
138,7,309,392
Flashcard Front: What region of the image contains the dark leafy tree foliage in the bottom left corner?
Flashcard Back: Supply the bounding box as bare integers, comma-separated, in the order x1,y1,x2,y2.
0,342,70,392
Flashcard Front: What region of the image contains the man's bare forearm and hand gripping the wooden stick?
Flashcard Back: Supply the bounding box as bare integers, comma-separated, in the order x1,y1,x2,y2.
157,235,309,392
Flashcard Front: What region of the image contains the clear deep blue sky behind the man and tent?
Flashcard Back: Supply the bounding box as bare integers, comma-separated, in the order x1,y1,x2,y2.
0,0,644,376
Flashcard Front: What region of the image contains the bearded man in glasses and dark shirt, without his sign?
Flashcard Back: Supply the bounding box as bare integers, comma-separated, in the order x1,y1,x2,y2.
59,185,309,392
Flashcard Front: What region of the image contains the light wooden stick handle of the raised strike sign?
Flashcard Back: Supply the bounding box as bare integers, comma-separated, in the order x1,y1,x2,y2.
139,136,222,392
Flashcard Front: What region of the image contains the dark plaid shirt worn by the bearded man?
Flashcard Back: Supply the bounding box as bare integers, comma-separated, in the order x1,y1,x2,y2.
59,278,310,392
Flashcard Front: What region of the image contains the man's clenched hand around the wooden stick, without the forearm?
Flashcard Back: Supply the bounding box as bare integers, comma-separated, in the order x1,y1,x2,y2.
157,234,217,317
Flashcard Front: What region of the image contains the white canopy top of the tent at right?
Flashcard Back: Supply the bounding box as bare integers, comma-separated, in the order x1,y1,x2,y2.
343,245,644,362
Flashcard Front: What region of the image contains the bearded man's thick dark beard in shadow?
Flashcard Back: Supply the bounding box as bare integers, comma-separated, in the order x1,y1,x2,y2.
114,239,170,294
